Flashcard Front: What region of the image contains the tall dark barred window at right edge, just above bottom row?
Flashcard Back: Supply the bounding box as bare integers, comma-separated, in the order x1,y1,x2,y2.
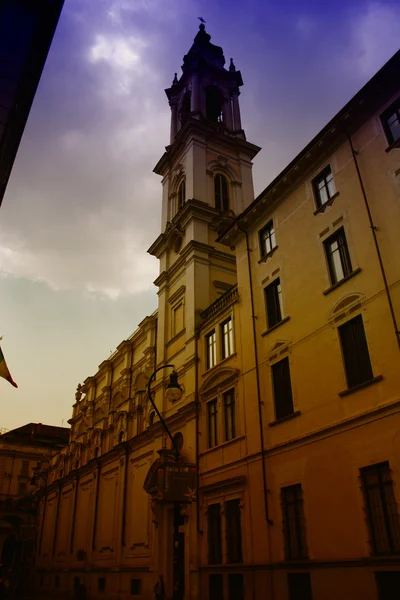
360,462,400,554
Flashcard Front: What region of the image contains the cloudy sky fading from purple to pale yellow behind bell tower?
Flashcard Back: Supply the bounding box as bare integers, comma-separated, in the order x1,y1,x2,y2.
0,0,400,428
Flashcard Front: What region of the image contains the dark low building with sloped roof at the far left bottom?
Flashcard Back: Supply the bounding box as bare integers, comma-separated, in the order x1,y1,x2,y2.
0,423,69,583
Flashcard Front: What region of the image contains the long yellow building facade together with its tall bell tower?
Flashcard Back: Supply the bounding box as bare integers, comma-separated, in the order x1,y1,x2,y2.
36,25,400,600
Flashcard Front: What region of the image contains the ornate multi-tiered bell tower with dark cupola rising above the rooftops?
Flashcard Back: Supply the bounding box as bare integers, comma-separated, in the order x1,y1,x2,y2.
149,23,260,384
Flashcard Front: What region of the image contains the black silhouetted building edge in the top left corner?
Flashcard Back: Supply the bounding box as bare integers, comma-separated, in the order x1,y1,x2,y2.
0,0,64,205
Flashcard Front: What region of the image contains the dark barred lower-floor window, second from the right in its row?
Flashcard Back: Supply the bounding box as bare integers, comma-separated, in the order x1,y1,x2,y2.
281,483,308,560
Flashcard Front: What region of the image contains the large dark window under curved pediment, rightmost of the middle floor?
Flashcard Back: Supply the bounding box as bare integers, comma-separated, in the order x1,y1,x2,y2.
339,315,373,388
